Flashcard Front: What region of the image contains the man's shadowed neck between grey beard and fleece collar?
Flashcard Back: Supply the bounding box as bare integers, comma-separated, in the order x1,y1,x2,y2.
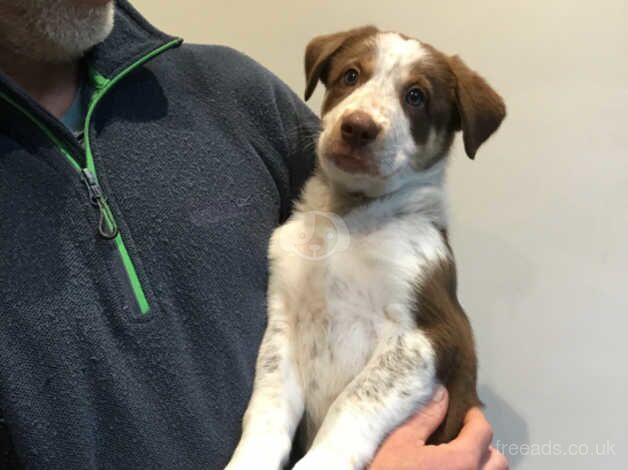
0,45,80,118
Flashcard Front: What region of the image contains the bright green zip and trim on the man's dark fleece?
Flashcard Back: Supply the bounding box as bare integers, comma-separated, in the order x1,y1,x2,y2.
0,38,183,315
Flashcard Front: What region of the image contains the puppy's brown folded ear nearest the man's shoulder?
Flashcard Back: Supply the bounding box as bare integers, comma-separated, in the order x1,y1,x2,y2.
305,26,379,101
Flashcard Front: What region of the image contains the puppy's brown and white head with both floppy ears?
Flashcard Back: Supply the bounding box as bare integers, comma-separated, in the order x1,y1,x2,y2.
305,26,505,196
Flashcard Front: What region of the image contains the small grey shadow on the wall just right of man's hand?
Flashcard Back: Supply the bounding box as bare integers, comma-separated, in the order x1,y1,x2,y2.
479,384,530,469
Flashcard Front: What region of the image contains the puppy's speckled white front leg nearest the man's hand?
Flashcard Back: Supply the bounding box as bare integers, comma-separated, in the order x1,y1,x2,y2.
294,330,436,470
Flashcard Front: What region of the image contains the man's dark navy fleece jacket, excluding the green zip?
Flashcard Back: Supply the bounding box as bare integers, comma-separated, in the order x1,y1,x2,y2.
0,1,319,470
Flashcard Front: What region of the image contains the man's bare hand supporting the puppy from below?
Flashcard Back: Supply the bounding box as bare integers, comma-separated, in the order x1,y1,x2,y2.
369,387,508,470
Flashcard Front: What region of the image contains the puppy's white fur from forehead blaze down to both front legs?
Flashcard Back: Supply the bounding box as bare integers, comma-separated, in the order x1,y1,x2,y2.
227,33,450,470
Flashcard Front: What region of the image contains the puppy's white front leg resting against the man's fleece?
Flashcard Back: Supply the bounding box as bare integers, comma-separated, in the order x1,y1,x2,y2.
226,293,303,470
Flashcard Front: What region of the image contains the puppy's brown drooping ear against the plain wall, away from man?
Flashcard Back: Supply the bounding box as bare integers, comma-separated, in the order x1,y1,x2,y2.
449,56,506,159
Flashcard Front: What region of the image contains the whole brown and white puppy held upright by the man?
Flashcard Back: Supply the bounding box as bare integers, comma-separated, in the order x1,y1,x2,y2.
227,26,505,470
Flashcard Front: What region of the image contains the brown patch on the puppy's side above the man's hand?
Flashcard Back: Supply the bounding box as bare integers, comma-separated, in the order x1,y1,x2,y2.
416,246,482,444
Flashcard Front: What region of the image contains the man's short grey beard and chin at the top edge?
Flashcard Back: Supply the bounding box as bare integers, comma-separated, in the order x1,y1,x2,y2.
0,0,114,63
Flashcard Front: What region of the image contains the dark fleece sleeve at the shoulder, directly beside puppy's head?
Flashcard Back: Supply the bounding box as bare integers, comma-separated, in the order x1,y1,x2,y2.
186,46,320,221
